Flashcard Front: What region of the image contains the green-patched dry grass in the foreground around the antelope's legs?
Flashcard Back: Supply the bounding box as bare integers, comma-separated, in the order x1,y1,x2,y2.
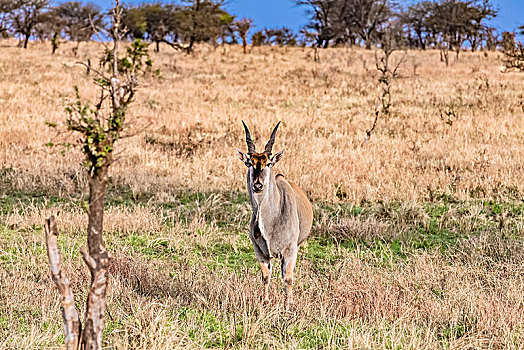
0,201,524,349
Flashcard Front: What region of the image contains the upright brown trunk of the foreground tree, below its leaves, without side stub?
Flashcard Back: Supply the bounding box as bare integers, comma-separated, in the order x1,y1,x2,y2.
82,164,111,350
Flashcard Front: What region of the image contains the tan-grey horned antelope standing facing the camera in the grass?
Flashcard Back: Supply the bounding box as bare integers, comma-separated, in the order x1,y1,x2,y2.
237,121,313,306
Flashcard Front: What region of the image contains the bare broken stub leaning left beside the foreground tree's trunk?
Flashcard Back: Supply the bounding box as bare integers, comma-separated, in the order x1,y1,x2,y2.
45,216,82,350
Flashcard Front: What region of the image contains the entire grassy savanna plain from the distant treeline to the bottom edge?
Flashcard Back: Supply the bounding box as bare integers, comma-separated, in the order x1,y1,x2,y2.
0,41,524,349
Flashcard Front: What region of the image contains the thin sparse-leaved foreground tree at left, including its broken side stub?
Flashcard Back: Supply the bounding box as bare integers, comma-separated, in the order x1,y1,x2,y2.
46,0,143,350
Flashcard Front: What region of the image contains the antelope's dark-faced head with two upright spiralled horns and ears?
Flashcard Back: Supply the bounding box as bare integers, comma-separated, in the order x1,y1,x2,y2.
237,121,284,193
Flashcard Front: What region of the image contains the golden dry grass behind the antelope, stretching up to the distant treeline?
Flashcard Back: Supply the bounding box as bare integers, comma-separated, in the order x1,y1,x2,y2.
0,42,524,202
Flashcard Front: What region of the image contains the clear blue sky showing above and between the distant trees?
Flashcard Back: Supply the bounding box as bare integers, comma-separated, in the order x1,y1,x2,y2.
91,0,524,31
